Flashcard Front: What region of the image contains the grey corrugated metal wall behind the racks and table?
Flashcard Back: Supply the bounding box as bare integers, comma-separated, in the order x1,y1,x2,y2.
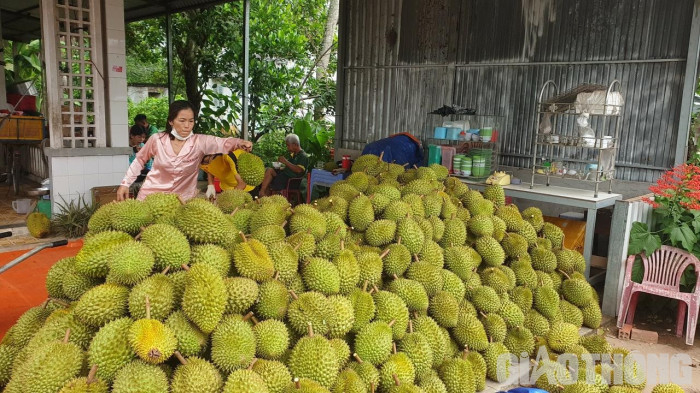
338,0,693,181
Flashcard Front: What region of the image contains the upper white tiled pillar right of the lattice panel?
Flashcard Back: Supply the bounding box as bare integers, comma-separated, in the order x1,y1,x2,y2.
104,0,131,147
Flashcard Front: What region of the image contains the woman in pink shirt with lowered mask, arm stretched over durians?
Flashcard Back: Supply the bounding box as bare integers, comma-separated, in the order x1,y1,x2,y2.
117,100,253,201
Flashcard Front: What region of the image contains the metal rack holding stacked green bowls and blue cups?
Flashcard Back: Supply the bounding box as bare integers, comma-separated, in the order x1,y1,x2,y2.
424,115,503,180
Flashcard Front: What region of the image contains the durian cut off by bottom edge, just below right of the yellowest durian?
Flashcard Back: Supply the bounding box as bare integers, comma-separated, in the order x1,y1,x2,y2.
170,351,224,393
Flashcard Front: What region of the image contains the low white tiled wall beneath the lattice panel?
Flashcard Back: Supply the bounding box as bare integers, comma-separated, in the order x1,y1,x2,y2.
50,155,129,212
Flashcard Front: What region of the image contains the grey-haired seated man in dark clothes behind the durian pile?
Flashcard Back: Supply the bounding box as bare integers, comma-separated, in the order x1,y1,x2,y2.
260,134,309,197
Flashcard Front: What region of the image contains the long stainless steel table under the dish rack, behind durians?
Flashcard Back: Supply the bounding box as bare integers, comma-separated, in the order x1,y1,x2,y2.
460,178,622,279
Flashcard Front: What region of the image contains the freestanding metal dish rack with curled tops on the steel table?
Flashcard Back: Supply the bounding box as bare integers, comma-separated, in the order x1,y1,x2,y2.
530,80,624,198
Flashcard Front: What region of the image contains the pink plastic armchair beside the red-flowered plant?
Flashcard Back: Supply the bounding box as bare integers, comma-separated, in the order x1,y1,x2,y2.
617,246,700,345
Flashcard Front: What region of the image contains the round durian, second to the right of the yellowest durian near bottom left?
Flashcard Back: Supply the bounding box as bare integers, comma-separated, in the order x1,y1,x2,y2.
211,313,256,373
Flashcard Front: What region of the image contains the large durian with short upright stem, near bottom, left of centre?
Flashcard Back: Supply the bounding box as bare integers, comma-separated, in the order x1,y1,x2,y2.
288,324,339,388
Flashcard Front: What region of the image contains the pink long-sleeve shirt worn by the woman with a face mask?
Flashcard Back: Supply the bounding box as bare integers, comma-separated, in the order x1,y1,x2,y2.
121,133,242,201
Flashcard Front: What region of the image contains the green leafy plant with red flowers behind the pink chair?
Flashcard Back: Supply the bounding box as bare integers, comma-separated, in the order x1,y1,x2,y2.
627,163,700,292
